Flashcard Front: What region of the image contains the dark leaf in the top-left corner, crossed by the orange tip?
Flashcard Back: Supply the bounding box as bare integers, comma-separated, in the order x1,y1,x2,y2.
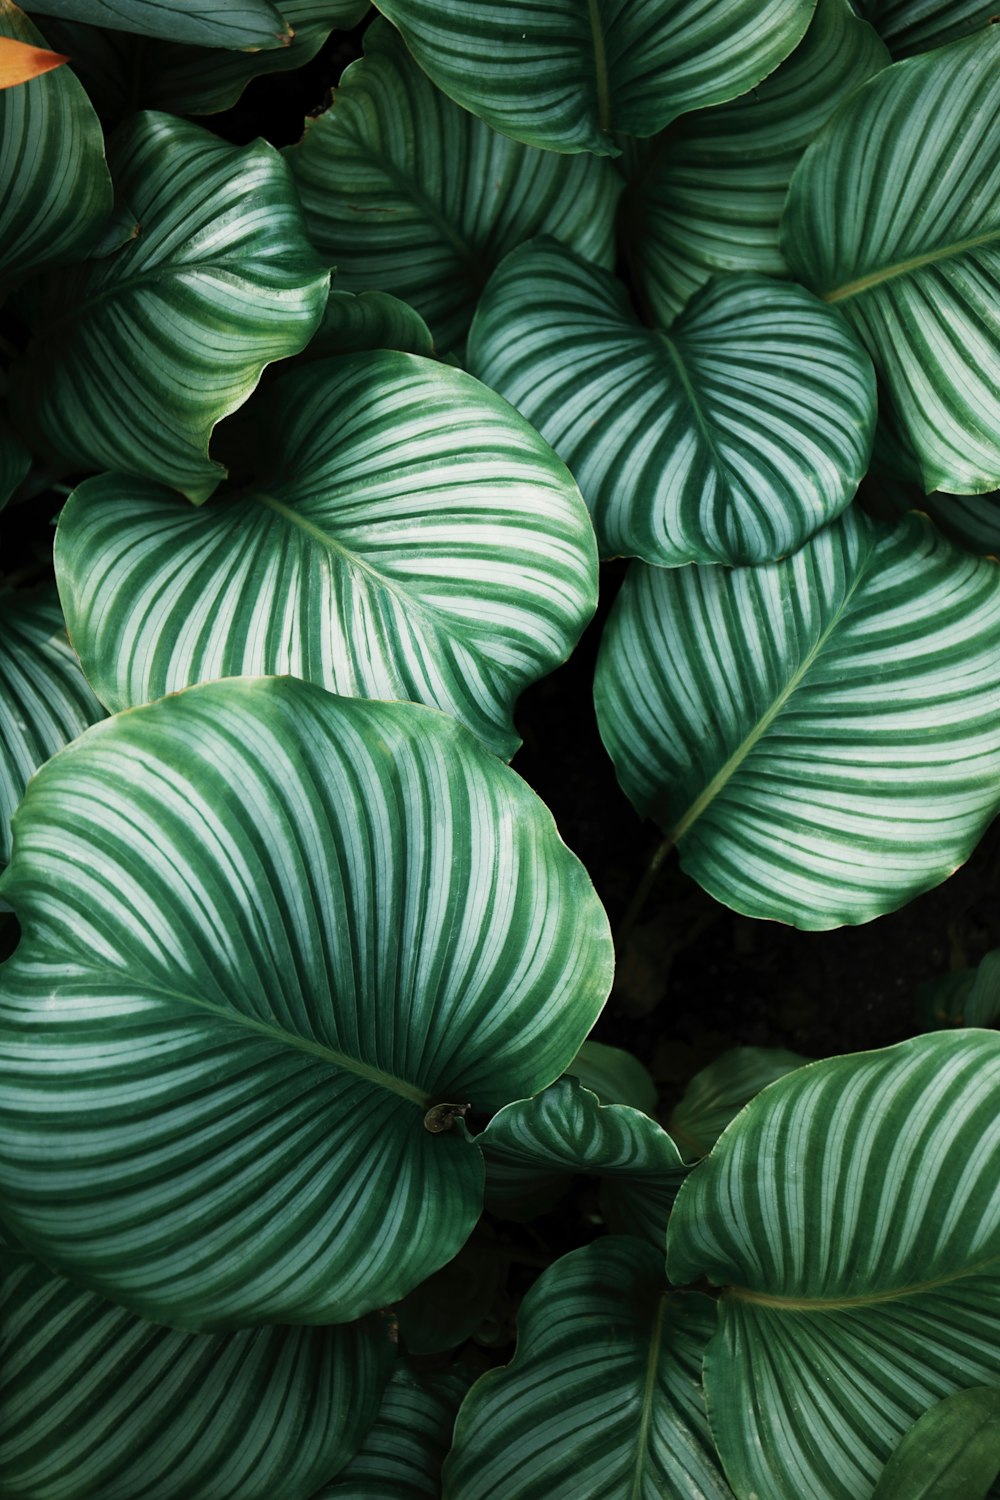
0,0,112,285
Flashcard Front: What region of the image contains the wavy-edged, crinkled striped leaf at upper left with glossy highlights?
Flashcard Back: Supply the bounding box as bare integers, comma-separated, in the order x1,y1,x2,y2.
12,114,328,501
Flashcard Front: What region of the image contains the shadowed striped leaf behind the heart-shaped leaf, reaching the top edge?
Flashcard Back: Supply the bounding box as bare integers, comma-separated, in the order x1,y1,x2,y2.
622,0,889,327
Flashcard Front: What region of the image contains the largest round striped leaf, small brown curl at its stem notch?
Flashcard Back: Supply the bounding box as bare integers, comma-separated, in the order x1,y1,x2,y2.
0,678,612,1331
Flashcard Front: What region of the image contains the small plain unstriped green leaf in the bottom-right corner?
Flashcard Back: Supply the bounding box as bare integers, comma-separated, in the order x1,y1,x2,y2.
871,1386,1000,1500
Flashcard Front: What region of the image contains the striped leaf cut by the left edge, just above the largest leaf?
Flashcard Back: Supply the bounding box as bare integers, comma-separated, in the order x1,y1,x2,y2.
0,588,103,869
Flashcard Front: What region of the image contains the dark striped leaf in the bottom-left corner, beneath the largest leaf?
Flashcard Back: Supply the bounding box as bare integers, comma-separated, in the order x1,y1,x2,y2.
0,1259,394,1500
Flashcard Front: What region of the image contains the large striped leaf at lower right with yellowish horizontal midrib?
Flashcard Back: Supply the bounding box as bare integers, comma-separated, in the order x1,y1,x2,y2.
667,1032,1000,1500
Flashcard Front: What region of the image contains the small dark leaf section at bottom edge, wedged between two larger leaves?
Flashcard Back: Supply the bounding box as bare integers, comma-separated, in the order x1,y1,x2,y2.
315,1364,469,1500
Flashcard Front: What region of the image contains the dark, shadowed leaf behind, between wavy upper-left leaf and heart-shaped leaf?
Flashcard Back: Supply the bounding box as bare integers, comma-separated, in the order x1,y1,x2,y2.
285,23,622,353
